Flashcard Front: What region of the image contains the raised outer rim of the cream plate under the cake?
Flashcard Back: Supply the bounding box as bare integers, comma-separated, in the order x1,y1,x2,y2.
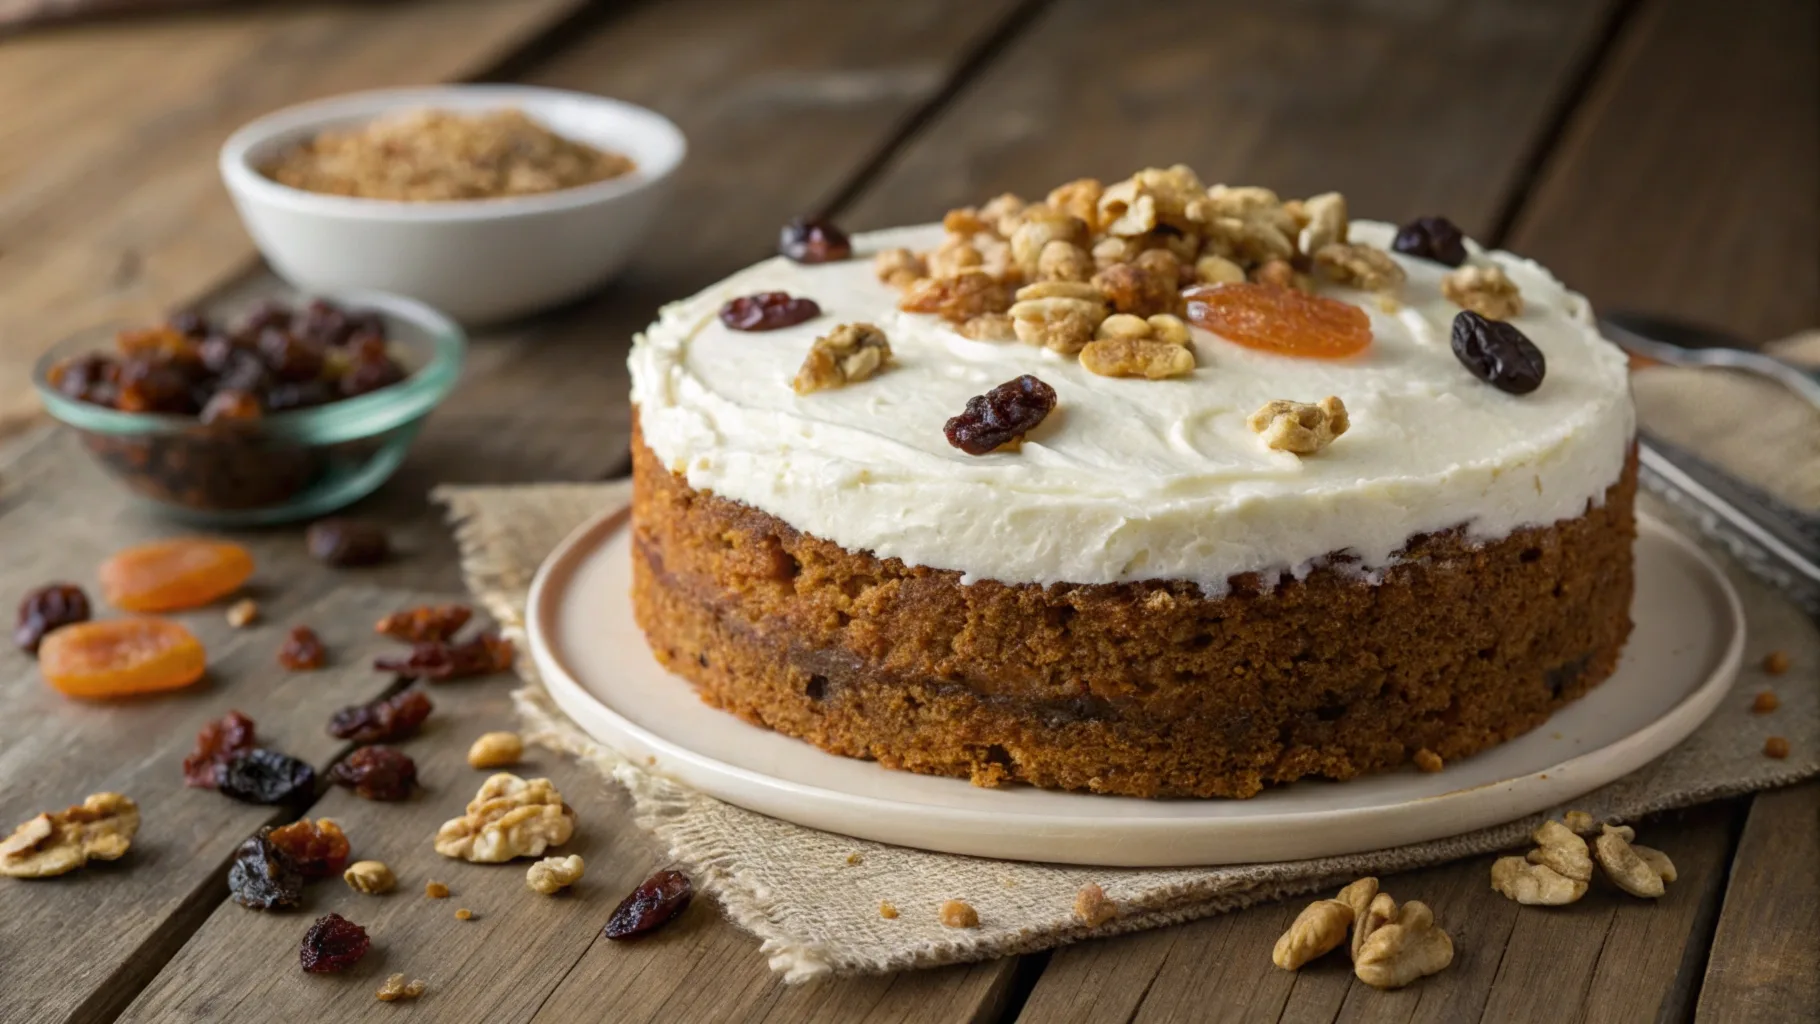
524,506,1745,868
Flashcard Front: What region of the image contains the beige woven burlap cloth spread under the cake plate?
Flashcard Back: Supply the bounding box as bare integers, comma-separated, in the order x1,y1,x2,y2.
437,352,1820,980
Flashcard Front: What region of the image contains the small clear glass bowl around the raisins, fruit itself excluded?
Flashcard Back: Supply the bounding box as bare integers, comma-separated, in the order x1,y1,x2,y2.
33,293,468,526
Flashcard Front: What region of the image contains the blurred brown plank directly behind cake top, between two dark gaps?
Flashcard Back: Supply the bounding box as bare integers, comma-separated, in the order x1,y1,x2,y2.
852,0,1611,233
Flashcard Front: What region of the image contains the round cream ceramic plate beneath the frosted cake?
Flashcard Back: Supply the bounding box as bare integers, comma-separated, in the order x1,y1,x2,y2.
528,513,1744,868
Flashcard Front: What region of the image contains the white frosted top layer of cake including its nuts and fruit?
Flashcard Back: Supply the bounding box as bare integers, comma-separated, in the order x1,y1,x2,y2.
632,169,1633,593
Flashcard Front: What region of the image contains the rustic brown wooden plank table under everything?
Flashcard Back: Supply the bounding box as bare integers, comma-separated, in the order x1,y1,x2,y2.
0,0,1820,1024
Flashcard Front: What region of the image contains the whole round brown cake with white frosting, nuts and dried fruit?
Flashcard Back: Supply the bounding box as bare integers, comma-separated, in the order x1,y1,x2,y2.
632,167,1636,797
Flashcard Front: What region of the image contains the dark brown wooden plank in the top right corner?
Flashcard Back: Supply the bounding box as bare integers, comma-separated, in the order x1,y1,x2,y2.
1511,0,1820,340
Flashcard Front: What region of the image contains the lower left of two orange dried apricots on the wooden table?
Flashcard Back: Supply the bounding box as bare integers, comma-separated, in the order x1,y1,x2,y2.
38,618,207,698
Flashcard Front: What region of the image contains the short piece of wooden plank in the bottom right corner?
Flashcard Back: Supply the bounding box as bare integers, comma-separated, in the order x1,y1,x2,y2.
1696,782,1820,1024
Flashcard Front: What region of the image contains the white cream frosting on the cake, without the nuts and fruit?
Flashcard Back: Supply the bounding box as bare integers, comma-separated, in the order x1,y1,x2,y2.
630,222,1634,595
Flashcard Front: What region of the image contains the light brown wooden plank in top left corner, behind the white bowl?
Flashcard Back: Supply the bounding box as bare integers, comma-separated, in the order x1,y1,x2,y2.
0,0,584,435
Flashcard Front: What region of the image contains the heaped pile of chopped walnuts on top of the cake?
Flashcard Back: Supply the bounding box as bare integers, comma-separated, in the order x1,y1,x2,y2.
875,166,1403,378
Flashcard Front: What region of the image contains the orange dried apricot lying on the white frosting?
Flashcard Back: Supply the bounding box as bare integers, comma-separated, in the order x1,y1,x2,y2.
1183,282,1370,358
